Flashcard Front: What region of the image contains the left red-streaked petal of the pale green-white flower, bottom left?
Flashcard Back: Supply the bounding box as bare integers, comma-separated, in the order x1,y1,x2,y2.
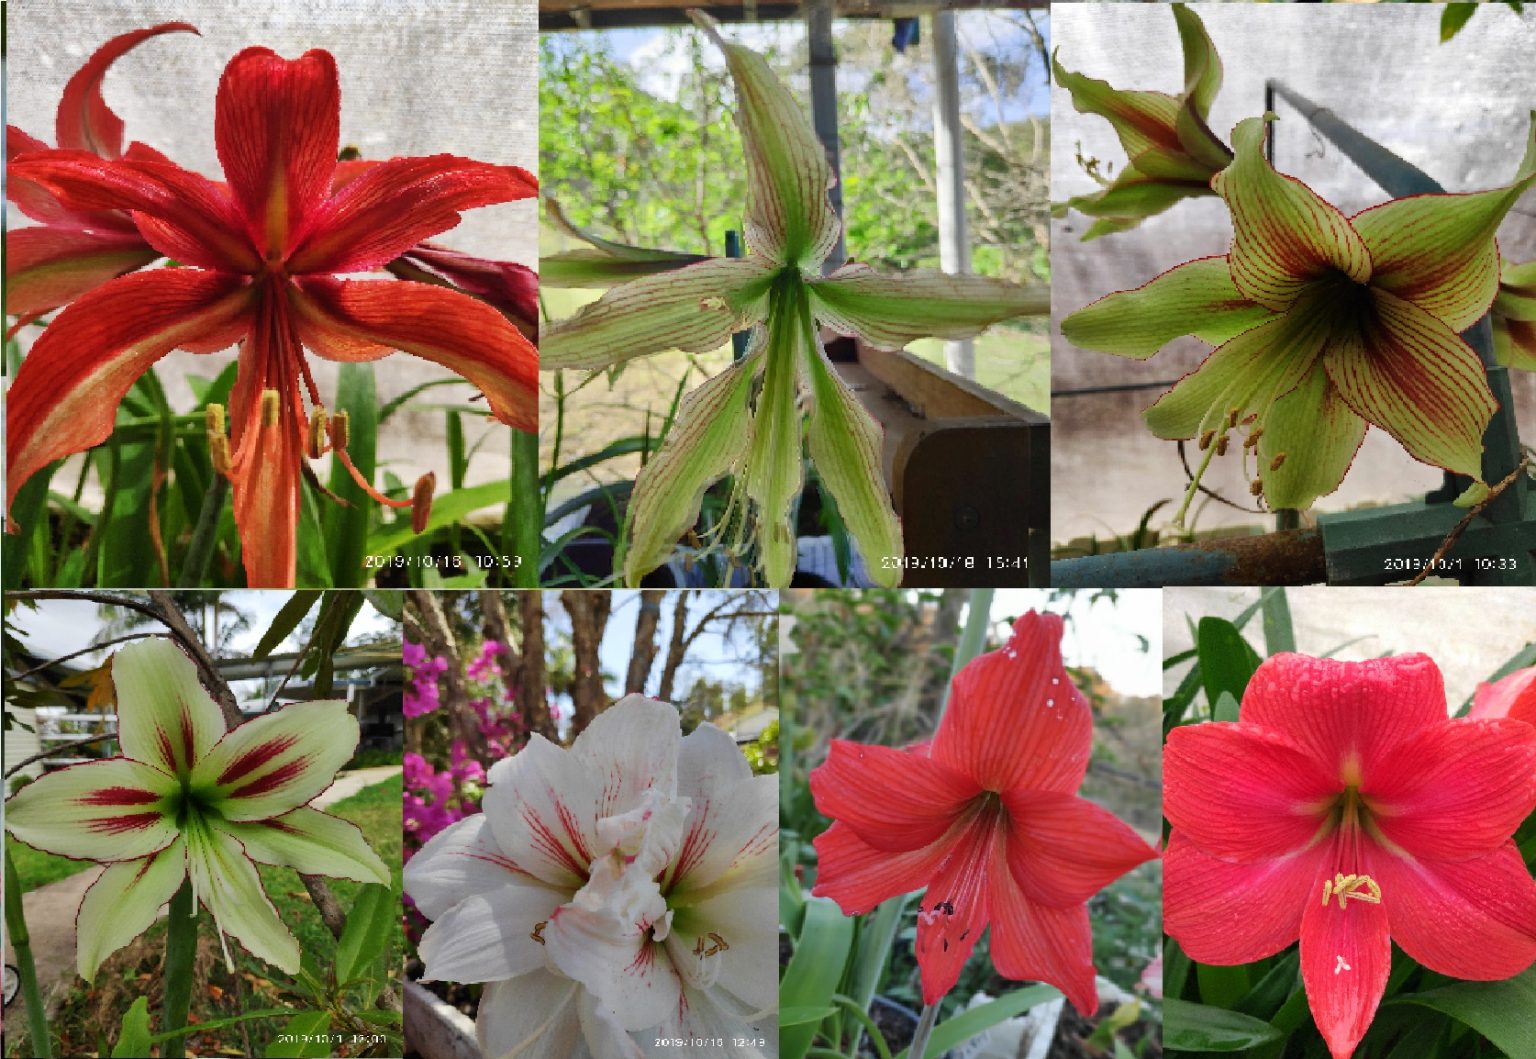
5,758,180,861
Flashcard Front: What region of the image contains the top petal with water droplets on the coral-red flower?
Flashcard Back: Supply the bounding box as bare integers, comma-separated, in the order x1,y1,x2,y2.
932,610,1094,795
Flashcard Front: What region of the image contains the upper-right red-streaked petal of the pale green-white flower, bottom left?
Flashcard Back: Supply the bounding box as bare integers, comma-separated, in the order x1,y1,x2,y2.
192,699,358,821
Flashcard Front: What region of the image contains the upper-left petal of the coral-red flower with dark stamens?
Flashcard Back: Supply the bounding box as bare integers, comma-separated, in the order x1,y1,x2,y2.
811,739,982,852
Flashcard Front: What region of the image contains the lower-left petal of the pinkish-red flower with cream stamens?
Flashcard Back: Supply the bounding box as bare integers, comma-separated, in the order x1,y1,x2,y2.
1163,830,1329,967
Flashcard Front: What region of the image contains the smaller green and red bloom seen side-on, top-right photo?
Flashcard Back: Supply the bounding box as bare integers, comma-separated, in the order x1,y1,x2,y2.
1051,3,1232,241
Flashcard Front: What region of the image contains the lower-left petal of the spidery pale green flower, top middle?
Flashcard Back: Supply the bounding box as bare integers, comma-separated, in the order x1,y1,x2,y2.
624,342,763,586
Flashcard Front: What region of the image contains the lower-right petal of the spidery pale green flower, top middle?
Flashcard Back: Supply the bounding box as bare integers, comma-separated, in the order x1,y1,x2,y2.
800,336,903,589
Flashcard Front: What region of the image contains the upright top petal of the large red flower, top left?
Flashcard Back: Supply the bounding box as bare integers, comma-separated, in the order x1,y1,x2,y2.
214,48,341,257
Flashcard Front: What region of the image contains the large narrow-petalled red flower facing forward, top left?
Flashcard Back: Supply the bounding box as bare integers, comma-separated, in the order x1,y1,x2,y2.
6,48,538,587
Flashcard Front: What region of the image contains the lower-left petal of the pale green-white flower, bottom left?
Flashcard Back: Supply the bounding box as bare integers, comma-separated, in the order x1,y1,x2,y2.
75,838,187,984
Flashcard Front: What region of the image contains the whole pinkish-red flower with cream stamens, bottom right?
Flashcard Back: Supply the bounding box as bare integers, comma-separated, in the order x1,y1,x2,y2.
1163,655,1536,1059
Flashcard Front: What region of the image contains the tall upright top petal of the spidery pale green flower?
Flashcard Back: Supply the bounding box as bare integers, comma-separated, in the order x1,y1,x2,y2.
688,11,842,272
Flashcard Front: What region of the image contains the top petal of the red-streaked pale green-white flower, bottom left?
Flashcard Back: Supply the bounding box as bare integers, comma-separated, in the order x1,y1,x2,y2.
112,638,224,776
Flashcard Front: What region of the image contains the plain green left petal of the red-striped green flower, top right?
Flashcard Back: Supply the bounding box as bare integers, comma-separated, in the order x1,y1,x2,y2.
1061,257,1275,360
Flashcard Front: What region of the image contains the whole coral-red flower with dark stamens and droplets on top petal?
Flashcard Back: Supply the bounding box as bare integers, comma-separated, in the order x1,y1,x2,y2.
811,612,1157,1014
